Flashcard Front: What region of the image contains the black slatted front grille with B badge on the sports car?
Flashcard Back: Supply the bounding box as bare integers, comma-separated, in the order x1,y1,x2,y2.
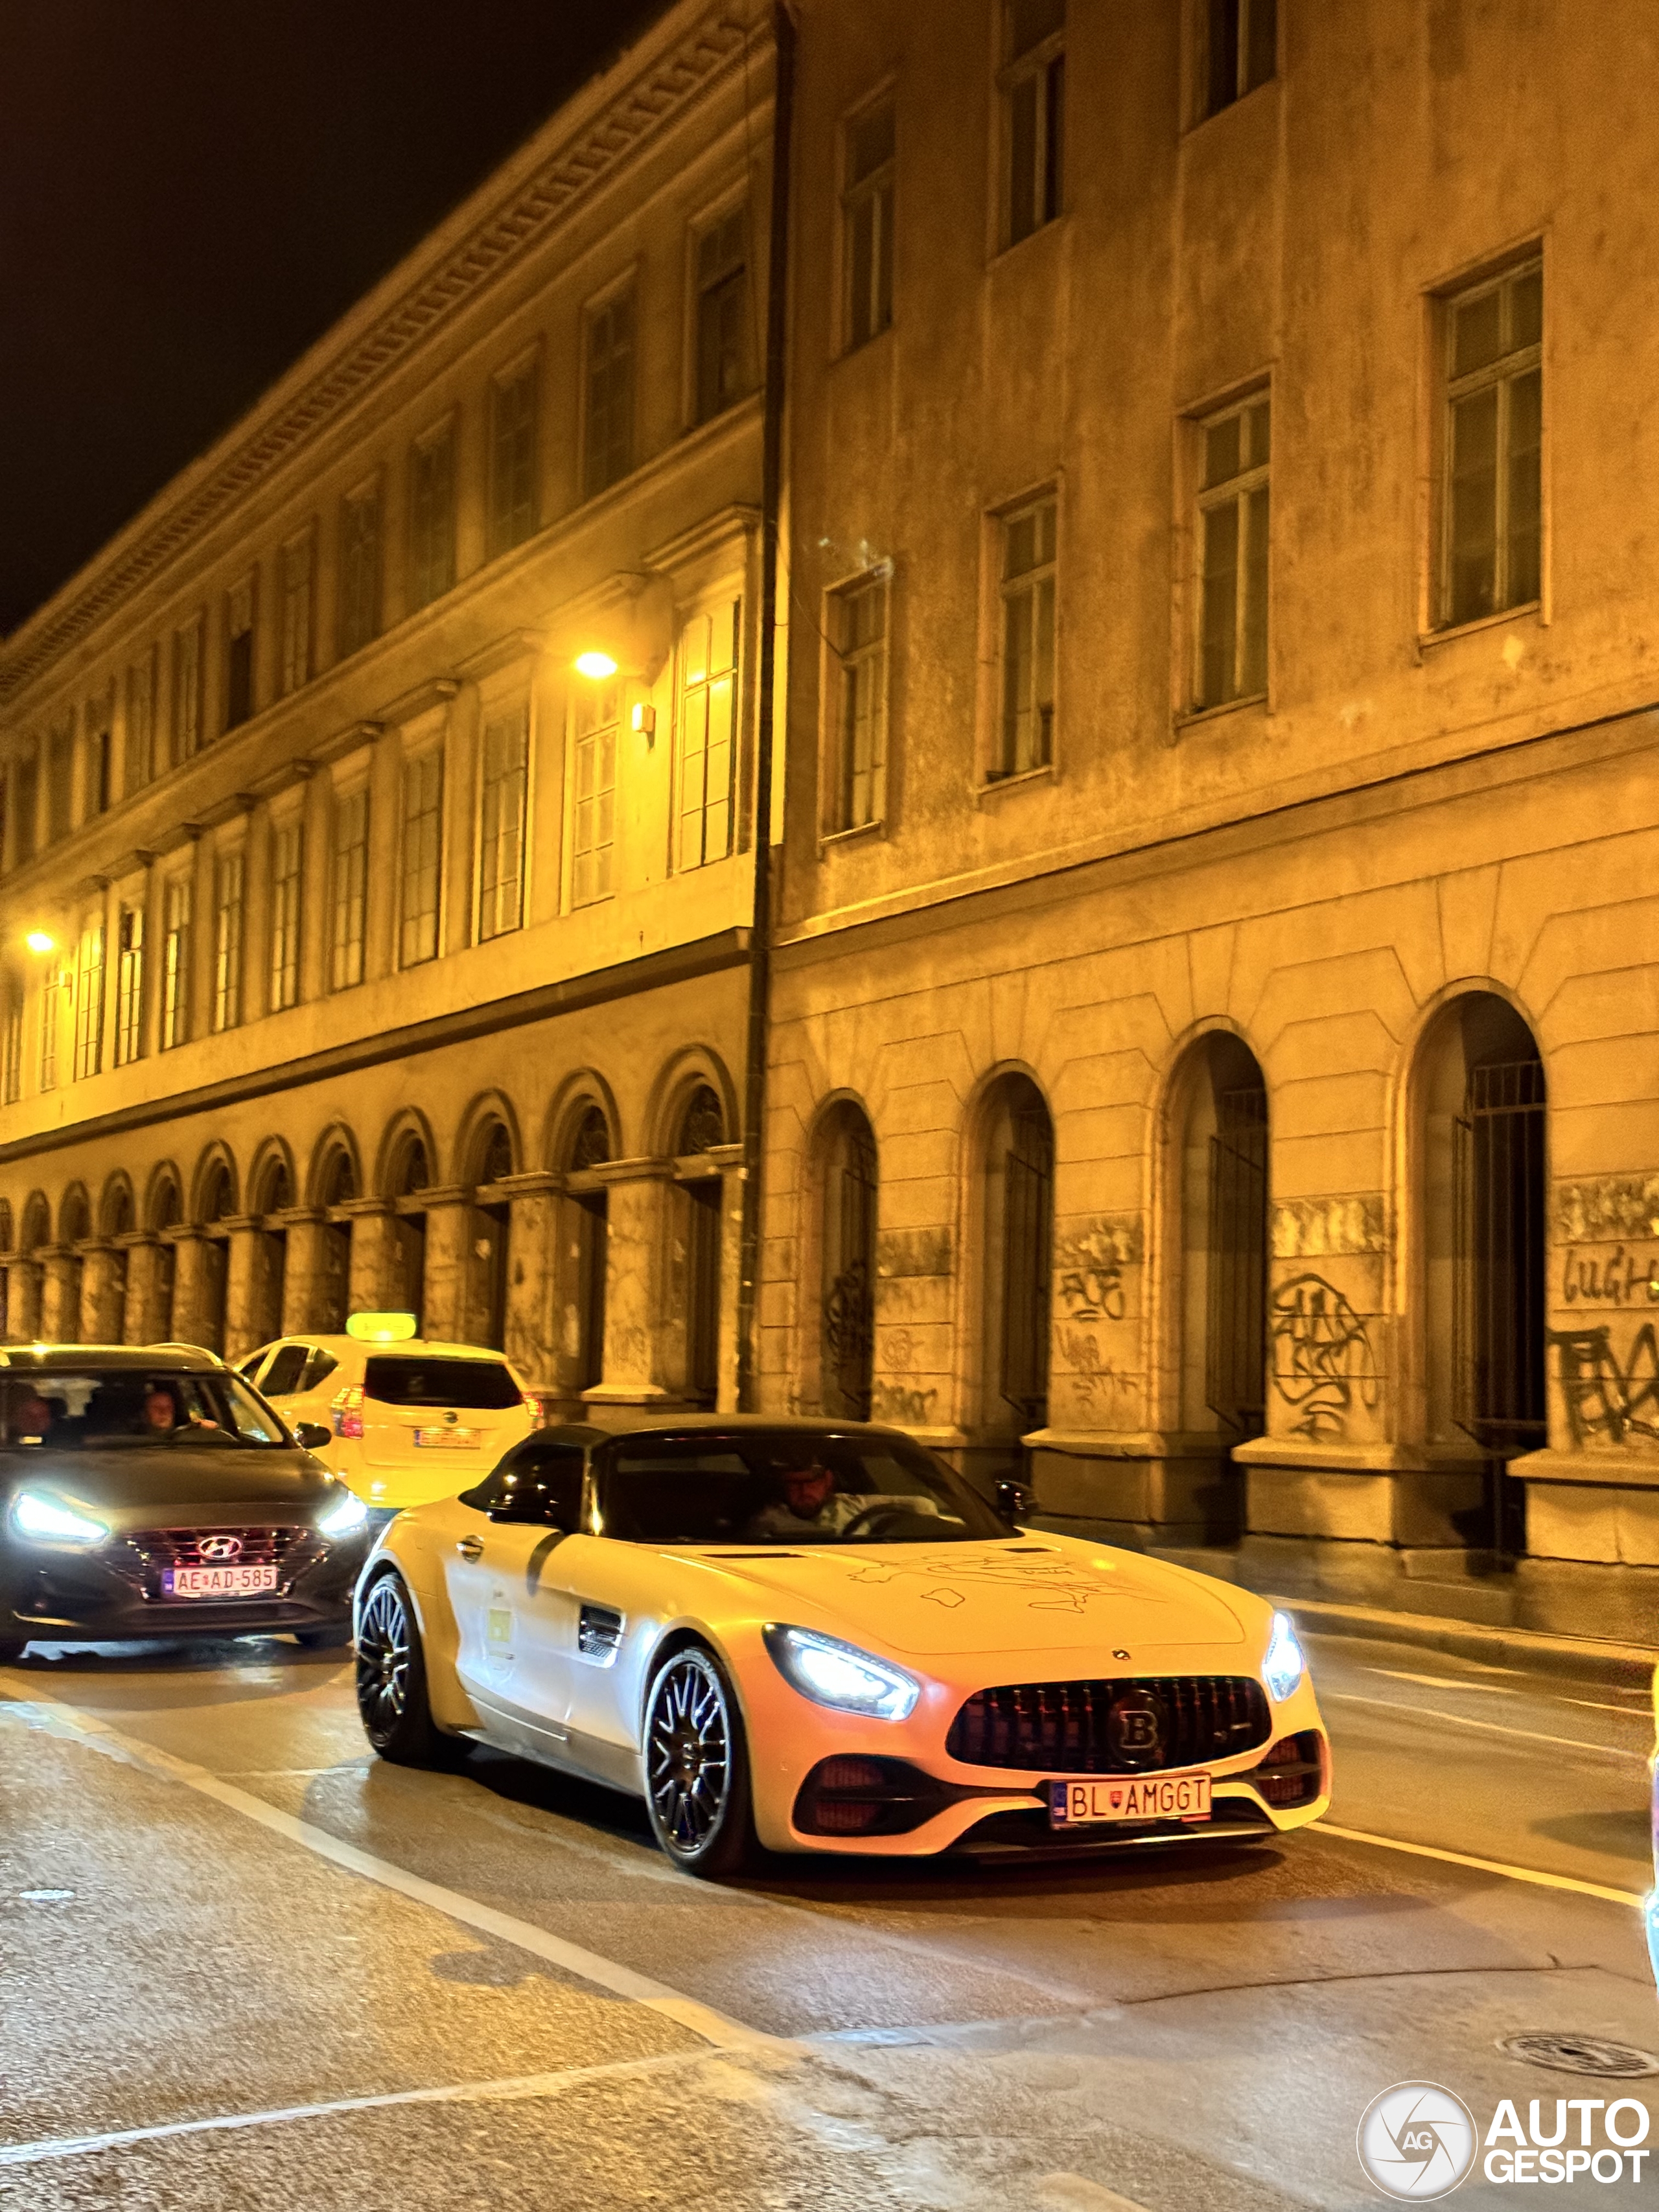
944,1675,1270,1774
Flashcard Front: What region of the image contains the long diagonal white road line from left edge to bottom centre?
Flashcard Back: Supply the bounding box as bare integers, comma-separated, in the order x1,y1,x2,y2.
6,1692,803,2053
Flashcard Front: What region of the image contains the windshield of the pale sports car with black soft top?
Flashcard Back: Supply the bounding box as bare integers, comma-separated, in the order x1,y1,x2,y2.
599,1429,1011,1548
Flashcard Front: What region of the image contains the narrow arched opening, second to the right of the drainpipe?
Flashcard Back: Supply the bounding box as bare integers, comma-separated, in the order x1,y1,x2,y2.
980,1075,1055,1442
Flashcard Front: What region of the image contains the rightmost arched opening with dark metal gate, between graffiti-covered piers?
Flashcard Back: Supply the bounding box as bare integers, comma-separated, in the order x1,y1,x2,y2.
1416,991,1548,1559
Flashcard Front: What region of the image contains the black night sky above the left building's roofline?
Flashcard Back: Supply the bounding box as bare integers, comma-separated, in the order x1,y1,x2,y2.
0,0,677,635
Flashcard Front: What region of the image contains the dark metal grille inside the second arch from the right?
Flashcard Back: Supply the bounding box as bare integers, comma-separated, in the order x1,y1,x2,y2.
1203,1084,1268,1438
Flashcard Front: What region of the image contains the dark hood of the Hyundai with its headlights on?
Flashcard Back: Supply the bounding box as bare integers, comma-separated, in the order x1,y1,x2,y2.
0,1445,334,1520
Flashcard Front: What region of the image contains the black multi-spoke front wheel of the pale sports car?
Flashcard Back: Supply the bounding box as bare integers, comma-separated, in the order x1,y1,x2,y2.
646,1644,754,1874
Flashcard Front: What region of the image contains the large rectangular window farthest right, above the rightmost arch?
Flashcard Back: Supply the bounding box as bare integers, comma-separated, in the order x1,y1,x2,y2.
1440,261,1544,626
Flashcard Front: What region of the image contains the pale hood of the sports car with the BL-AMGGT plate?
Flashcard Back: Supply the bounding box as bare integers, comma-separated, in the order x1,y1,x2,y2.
686,1537,1250,1659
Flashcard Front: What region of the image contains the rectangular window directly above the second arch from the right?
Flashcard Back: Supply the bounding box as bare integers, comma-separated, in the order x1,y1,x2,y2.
1192,391,1272,708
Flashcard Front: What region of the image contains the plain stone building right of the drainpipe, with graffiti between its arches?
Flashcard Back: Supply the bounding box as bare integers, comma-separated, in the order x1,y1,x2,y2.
761,0,1659,1637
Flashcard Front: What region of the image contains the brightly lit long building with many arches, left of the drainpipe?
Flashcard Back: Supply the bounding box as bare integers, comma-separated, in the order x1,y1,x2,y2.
0,0,772,1407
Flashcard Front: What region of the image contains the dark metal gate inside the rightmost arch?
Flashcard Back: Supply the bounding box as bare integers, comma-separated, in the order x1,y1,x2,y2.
1451,1060,1548,1557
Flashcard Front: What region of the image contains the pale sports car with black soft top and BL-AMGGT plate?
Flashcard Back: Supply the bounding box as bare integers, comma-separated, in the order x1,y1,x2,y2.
356,1414,1329,1874
